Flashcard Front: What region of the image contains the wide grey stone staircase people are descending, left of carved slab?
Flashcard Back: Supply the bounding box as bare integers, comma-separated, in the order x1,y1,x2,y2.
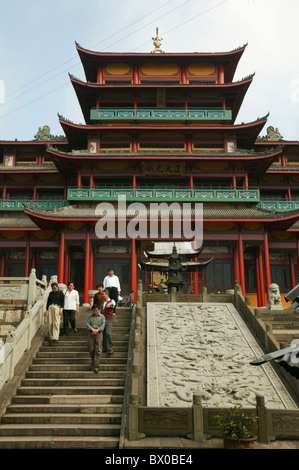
0,307,131,449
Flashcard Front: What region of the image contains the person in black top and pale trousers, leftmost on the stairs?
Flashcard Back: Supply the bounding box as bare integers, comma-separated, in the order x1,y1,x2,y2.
44,282,64,345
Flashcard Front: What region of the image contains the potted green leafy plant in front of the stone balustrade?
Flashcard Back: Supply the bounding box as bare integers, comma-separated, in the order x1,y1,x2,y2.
214,406,259,449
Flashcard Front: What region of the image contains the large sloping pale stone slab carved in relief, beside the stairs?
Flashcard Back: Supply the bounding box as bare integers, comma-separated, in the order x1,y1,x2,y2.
147,303,297,409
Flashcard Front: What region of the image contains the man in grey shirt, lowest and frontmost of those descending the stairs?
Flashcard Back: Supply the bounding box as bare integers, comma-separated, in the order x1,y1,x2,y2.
86,305,106,374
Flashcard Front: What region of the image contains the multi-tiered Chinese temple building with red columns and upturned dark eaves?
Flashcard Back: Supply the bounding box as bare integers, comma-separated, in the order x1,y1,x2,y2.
0,37,299,306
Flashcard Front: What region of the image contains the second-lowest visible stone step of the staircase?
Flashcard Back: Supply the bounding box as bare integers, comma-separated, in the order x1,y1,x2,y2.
0,423,120,437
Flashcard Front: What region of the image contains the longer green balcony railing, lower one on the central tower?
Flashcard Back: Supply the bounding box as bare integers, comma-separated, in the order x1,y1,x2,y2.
67,187,260,203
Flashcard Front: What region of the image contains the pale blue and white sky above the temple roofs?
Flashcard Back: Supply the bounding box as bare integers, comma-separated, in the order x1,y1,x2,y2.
0,0,299,141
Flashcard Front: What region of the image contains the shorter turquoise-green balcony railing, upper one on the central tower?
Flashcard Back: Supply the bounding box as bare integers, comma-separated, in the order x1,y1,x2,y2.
90,108,232,121
